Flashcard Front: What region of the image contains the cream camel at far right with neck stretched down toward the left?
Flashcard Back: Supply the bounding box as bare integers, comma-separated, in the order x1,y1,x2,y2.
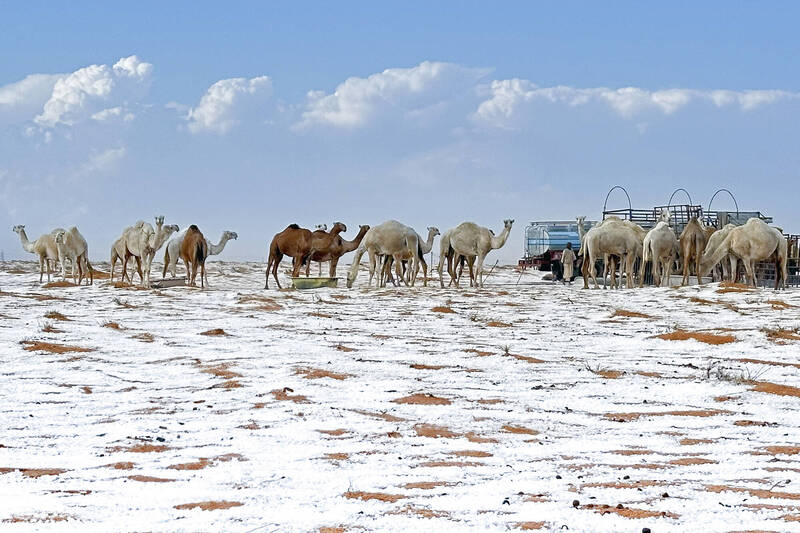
697,218,788,290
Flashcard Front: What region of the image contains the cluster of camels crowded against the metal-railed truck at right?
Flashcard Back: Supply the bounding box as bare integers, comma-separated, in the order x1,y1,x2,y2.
577,209,788,289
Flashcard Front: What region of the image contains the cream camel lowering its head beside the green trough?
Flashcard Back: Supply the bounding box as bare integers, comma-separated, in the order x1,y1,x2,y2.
347,220,419,289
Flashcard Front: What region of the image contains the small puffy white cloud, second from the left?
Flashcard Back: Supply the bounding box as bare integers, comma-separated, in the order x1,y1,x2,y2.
186,76,272,134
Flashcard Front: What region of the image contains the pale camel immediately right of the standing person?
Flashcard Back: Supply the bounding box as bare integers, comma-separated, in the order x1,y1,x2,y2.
580,216,646,289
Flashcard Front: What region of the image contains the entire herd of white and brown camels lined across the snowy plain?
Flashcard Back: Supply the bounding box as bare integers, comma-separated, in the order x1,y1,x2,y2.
13,210,787,289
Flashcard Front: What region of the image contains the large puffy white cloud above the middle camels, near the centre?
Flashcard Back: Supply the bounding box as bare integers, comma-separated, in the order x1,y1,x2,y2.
295,61,488,129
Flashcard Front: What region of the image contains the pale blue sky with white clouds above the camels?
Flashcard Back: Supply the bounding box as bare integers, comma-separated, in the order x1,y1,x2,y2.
0,1,800,263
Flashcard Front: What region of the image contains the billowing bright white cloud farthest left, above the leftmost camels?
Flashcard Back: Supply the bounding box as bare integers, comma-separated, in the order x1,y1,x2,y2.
35,56,153,128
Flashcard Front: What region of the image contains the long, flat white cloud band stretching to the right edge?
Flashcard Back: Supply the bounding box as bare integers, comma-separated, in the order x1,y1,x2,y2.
473,79,800,128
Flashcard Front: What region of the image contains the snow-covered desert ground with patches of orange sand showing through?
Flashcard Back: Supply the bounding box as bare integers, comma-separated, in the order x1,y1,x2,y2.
0,262,800,533
